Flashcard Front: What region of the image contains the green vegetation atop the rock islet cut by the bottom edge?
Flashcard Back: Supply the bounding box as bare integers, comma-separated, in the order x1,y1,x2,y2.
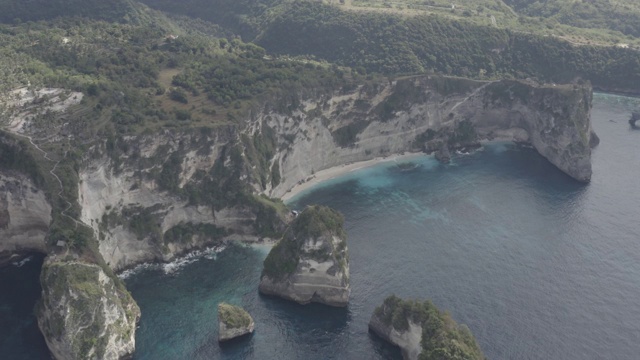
375,295,485,360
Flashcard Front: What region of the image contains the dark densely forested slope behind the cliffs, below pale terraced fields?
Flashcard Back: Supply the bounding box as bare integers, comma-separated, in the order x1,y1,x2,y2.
257,2,640,91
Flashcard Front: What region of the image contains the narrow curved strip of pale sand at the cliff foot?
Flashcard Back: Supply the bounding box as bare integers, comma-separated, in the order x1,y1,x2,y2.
281,152,425,202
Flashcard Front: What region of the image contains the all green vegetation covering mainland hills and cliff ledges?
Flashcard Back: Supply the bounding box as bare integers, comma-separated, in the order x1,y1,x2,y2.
0,0,640,284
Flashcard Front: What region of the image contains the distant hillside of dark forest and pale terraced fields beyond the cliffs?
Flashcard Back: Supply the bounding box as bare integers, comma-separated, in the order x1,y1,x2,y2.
143,0,640,93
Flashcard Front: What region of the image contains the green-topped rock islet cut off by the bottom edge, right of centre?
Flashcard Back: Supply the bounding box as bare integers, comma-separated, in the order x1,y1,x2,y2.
369,295,485,360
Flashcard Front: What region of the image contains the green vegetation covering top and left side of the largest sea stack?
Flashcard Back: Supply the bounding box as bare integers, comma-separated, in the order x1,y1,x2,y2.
263,205,346,279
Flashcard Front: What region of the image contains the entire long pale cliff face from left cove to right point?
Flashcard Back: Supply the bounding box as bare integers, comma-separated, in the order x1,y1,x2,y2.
72,76,591,270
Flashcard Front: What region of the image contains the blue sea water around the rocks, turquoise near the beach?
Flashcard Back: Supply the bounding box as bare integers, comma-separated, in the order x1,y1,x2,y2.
0,94,640,360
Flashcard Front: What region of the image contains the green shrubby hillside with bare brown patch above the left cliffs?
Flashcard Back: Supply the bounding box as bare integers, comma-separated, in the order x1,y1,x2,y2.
0,8,362,260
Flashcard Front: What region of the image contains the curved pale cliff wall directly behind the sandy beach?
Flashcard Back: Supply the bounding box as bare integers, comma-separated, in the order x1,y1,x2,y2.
265,76,592,197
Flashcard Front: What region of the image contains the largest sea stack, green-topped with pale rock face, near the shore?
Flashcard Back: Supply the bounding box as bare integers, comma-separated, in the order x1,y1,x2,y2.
260,206,351,306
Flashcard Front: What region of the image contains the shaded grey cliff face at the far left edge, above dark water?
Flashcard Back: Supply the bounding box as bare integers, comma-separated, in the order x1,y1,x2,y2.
0,172,51,266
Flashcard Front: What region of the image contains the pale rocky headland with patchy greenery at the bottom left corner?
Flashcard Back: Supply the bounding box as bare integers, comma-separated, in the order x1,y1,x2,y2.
37,258,140,360
